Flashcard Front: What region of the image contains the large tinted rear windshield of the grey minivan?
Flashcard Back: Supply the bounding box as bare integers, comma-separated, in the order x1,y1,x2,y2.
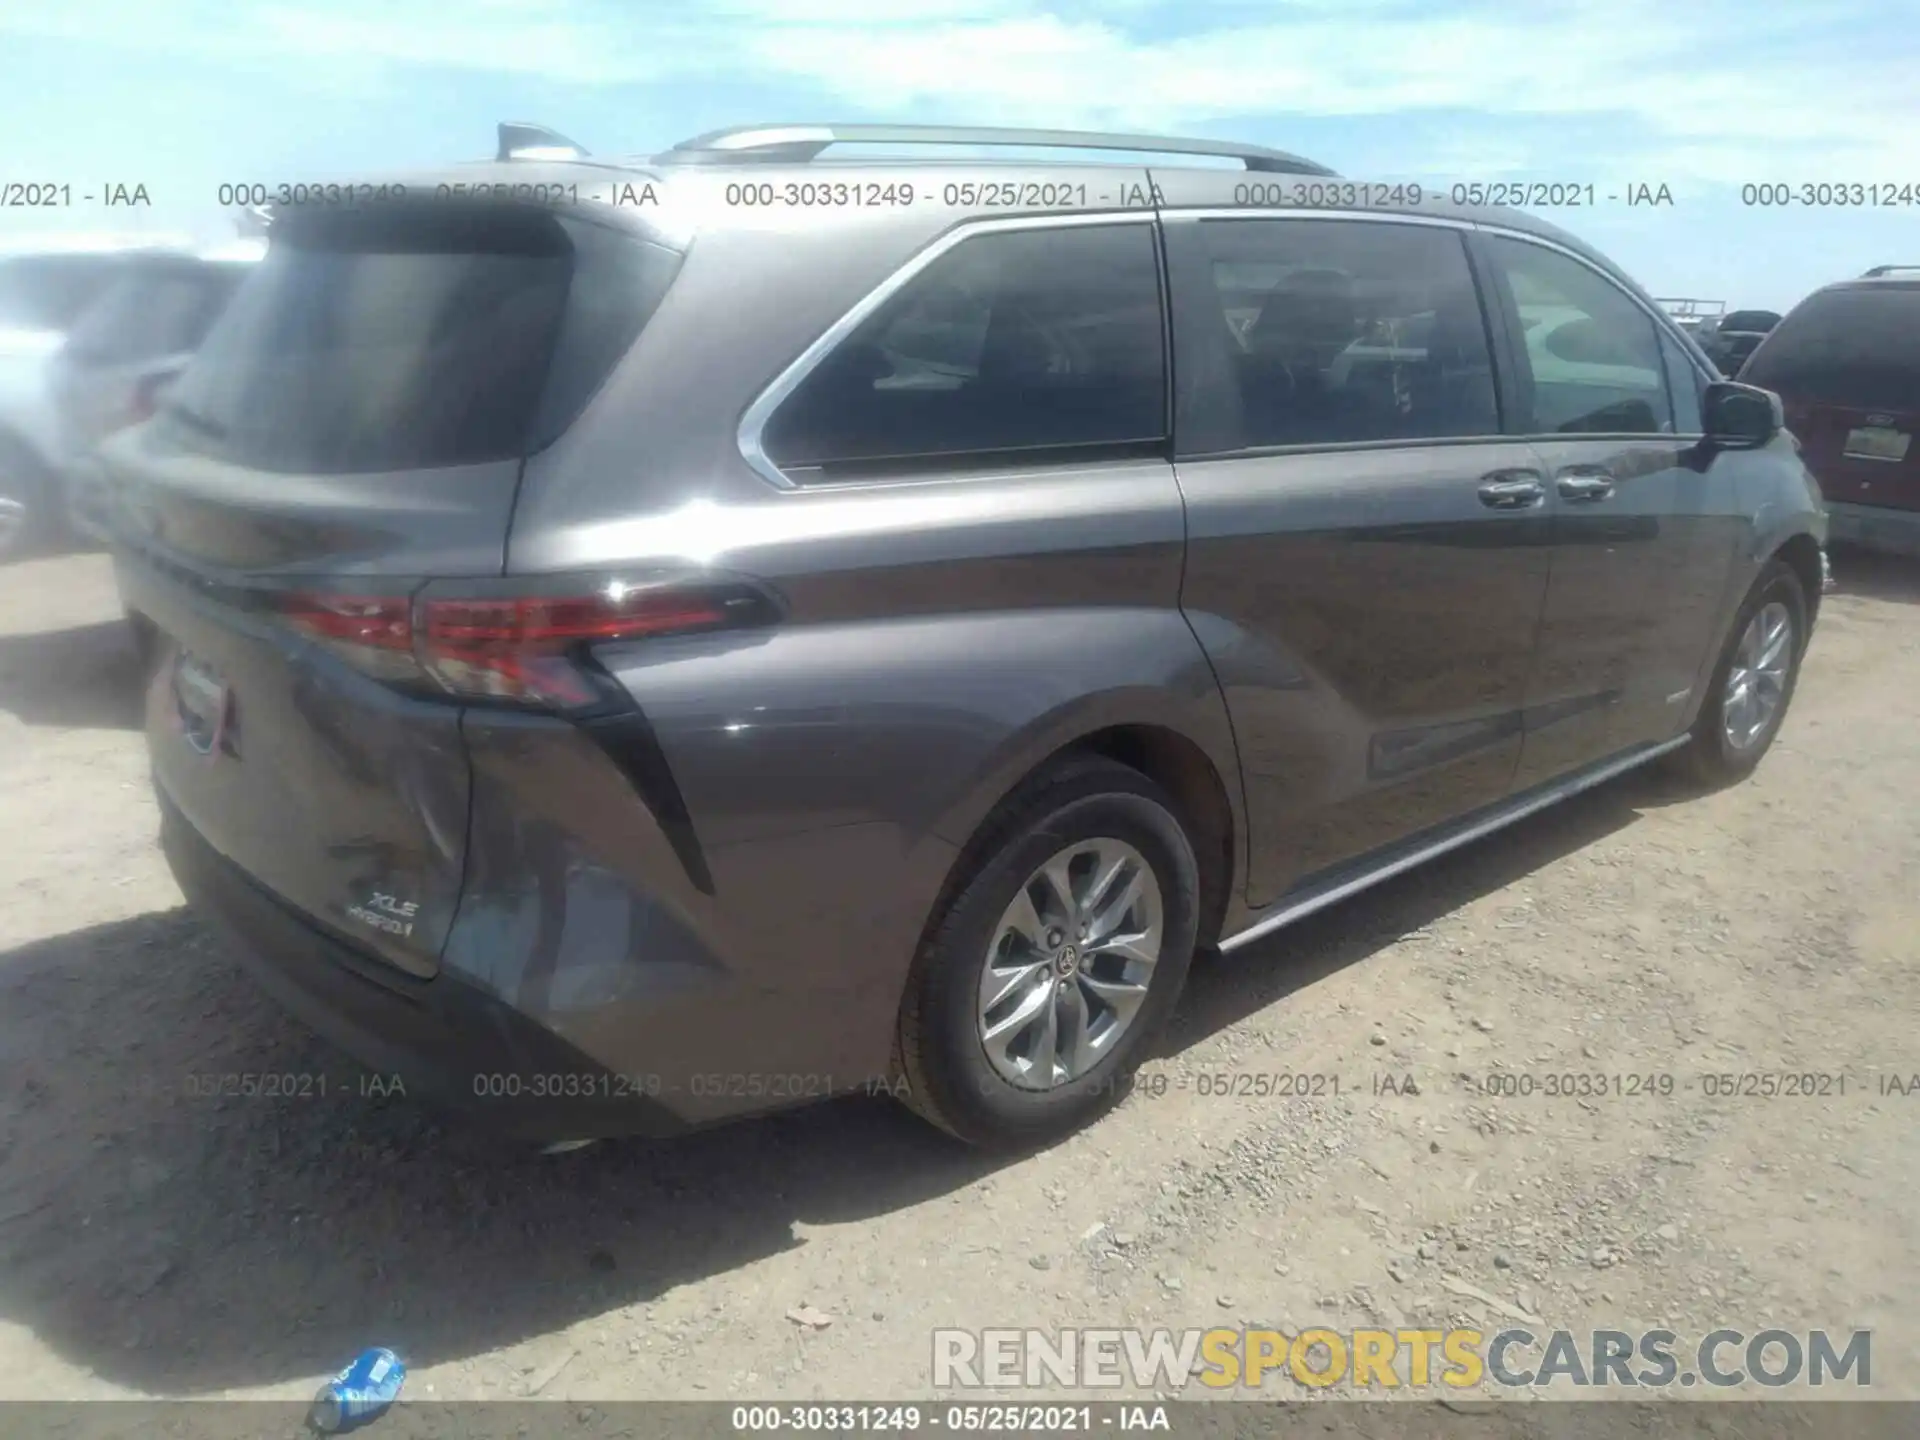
167,207,680,474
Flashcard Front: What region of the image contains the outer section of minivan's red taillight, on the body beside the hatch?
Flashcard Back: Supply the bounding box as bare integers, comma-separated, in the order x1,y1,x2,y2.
417,588,728,707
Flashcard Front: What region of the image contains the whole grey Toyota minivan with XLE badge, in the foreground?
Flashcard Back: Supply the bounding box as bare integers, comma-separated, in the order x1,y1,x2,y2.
108,127,1822,1142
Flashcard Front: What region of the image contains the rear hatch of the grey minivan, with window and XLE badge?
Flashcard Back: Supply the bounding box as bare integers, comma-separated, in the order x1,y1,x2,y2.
102,202,678,975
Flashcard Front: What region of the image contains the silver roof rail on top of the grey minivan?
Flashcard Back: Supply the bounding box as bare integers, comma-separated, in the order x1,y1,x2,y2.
655,125,1336,175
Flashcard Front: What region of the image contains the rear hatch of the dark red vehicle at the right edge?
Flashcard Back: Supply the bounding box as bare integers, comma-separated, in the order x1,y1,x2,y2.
1740,280,1920,511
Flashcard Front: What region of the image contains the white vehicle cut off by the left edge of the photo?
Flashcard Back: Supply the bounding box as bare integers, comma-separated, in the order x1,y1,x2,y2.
0,234,184,559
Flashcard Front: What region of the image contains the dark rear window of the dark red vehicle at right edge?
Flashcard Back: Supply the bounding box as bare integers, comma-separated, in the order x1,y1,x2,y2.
1740,286,1920,409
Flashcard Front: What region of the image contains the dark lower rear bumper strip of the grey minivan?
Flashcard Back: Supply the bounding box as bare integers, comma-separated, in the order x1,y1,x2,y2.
159,793,691,1140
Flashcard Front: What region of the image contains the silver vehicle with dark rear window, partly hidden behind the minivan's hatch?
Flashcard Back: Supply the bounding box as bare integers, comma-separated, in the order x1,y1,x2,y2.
48,238,267,543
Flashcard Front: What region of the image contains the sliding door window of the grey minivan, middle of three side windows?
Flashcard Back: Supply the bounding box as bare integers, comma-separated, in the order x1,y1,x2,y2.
1181,219,1500,451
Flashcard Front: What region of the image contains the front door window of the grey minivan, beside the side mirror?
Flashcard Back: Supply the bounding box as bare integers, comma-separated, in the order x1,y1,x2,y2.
1488,236,1674,434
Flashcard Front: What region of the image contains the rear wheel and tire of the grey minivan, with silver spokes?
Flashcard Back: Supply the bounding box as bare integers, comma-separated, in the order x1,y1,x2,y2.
895,756,1200,1148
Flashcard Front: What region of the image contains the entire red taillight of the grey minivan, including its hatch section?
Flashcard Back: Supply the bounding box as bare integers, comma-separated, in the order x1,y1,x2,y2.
280,582,774,710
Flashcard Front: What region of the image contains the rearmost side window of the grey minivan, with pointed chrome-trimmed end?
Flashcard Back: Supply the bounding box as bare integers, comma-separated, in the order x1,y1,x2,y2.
760,225,1167,482
